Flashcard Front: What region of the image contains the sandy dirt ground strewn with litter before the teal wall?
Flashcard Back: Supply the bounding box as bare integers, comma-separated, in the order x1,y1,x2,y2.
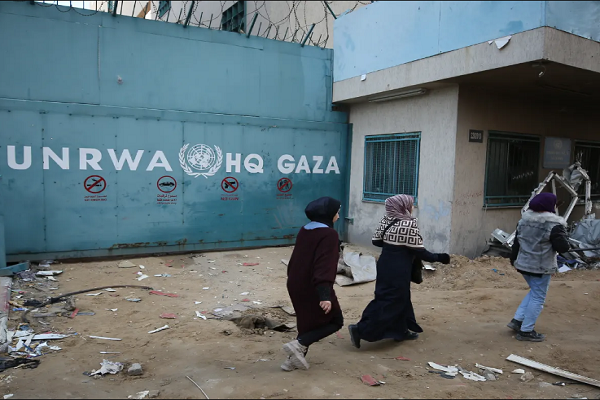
0,247,600,399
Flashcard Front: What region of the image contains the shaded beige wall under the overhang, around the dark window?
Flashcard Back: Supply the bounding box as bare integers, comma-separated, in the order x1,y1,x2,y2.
450,86,600,257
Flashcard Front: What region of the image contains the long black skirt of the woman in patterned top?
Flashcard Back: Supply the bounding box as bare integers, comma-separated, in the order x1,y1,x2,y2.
357,245,423,342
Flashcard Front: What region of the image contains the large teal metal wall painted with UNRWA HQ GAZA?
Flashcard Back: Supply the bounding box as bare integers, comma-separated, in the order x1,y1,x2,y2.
0,2,349,261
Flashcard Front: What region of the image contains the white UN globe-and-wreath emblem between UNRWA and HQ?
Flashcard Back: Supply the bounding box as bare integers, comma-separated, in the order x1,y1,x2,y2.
179,143,223,178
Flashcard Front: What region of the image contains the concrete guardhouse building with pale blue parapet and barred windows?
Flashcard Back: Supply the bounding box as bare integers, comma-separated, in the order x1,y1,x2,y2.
333,1,600,257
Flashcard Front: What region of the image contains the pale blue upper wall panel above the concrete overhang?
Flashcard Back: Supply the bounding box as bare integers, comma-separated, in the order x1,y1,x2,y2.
333,1,600,82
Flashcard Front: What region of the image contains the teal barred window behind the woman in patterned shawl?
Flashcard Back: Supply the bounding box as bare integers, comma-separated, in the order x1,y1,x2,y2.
363,132,421,203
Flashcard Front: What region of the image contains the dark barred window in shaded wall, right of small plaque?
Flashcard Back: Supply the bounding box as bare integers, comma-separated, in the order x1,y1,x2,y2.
484,131,540,207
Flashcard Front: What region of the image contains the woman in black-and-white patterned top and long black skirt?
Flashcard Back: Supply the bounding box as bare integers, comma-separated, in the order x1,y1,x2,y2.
348,194,450,348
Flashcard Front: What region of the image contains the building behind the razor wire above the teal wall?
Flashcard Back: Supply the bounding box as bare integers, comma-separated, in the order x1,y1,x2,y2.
91,1,372,48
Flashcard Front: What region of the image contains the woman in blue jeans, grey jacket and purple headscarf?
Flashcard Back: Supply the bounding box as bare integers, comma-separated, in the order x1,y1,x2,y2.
508,193,570,342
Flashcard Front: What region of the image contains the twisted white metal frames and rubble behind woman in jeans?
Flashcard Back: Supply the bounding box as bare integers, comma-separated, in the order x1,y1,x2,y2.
484,162,600,272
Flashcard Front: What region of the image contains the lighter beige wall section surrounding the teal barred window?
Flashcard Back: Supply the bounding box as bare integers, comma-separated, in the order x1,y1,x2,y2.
348,85,458,252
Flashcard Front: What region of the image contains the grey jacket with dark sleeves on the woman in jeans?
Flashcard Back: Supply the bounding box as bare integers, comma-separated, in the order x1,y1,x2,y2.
511,210,570,274
